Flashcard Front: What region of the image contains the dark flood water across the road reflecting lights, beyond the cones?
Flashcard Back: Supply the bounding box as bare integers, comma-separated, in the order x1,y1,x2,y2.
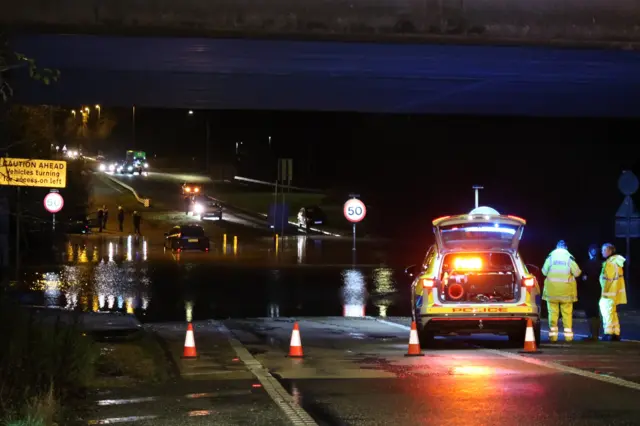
21,236,410,322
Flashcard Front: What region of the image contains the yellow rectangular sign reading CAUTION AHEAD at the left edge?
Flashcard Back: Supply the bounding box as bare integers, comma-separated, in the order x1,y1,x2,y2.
0,157,67,188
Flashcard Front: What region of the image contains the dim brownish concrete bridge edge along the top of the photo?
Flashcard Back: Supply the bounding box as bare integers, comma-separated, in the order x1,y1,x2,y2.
0,0,640,44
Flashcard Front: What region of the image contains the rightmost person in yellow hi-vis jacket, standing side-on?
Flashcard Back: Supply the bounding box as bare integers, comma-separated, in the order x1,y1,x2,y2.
600,243,627,341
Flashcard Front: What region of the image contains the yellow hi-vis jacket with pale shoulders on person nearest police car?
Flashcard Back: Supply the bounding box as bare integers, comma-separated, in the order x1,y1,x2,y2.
542,248,582,303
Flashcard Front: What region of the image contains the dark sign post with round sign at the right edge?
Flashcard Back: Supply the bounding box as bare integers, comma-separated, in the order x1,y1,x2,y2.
615,170,640,302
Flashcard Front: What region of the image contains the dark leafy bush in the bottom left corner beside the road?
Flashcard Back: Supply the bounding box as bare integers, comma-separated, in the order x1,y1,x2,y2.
0,300,97,426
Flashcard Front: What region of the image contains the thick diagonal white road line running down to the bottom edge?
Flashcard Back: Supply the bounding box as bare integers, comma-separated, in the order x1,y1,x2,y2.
218,322,318,426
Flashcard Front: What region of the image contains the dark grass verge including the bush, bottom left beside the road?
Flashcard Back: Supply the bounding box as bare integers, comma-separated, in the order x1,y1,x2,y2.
0,299,171,426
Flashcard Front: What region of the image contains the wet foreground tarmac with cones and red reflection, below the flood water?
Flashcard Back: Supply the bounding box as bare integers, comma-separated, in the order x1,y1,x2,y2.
81,317,640,426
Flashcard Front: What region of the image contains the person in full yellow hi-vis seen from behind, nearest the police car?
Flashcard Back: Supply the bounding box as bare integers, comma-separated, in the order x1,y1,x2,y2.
542,240,582,342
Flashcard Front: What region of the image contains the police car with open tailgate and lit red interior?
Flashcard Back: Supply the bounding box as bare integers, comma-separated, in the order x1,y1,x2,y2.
405,207,540,347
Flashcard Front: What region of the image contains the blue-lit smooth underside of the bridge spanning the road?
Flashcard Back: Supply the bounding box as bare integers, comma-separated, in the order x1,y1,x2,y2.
7,35,640,117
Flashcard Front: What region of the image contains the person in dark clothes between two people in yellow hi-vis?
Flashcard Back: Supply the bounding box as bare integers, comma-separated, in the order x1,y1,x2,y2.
580,244,602,342
